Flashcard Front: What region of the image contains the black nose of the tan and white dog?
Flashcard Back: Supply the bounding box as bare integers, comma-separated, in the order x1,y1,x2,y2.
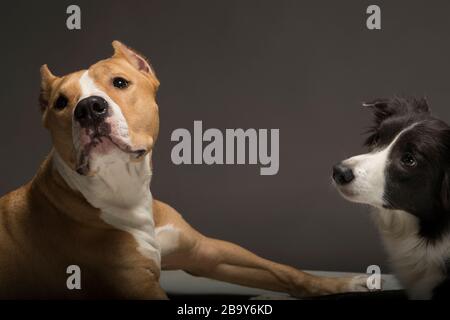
74,96,108,126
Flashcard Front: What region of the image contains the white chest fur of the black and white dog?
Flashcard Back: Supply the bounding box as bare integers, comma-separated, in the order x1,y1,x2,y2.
374,209,450,299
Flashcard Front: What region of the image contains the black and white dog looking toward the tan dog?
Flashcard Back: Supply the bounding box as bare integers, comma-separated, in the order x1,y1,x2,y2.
333,98,450,299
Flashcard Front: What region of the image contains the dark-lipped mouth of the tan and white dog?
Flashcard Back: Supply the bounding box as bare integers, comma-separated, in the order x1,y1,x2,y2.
76,132,148,176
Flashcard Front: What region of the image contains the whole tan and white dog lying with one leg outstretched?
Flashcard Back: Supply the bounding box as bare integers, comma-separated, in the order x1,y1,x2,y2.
0,41,367,299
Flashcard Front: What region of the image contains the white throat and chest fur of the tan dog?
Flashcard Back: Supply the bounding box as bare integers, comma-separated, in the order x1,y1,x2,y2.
53,150,161,266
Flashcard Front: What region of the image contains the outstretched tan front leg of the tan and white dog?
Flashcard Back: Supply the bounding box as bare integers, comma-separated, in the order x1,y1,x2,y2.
154,201,367,297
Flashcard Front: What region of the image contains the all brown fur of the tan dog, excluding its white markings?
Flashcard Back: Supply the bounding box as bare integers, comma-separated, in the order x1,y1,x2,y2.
0,41,368,299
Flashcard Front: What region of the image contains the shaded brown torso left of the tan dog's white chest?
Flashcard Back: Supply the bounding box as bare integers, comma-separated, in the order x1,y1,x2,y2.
0,154,165,298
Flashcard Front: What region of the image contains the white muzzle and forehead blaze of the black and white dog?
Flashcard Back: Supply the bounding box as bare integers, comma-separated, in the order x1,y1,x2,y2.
338,123,416,208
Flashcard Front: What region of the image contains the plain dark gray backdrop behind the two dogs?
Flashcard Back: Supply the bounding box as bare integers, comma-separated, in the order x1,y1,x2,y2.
0,0,450,271
